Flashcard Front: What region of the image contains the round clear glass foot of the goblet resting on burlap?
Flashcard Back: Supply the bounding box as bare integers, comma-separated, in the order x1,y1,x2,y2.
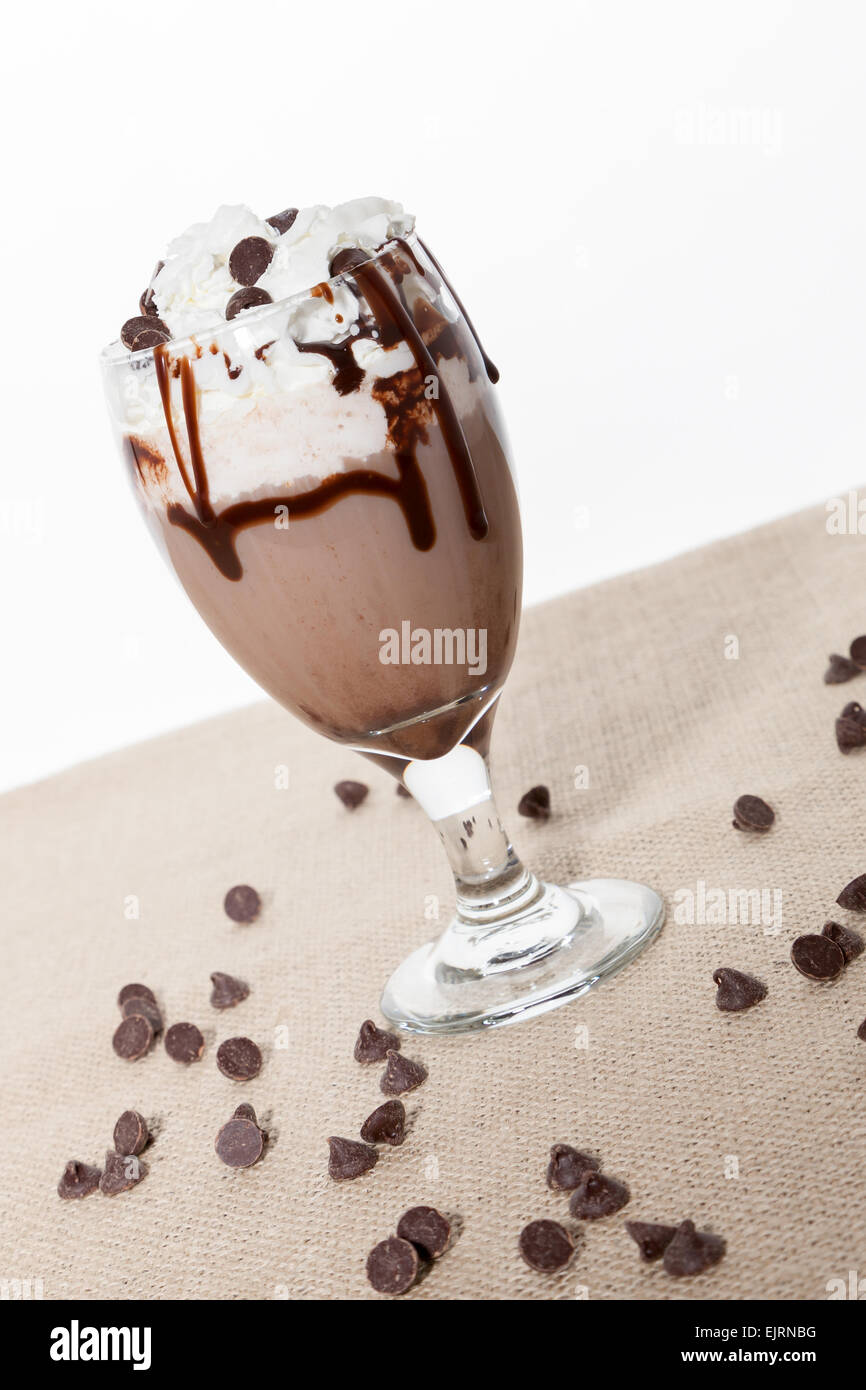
381,878,664,1033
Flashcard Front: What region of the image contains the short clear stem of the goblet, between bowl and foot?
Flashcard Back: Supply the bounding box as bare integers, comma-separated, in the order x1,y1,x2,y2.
403,744,542,930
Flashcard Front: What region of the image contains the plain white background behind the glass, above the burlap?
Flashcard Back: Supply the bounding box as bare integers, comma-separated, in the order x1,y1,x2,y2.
0,0,866,787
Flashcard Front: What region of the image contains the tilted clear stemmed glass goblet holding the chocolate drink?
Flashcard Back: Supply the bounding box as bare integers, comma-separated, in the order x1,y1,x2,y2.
101,235,663,1033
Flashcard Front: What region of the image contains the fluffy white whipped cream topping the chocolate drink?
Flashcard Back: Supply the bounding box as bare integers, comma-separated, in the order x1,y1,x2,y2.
103,197,492,505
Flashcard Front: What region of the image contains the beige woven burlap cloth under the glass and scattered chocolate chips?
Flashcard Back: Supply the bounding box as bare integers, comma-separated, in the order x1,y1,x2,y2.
0,510,866,1300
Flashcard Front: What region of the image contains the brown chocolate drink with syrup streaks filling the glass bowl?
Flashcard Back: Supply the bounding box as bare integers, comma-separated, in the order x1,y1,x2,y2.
115,222,521,773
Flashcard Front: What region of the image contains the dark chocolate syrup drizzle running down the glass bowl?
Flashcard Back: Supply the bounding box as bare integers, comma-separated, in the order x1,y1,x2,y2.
148,239,499,581
